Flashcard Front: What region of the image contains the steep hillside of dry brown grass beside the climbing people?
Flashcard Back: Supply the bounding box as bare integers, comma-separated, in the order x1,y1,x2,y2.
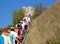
25,2,60,44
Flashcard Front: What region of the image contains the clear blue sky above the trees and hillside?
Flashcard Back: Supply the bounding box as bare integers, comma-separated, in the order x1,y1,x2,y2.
0,0,56,28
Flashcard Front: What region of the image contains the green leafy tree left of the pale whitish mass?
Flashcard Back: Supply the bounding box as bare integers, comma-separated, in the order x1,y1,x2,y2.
13,9,24,24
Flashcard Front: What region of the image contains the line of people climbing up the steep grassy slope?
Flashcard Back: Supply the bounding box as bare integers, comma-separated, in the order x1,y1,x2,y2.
0,15,31,44
